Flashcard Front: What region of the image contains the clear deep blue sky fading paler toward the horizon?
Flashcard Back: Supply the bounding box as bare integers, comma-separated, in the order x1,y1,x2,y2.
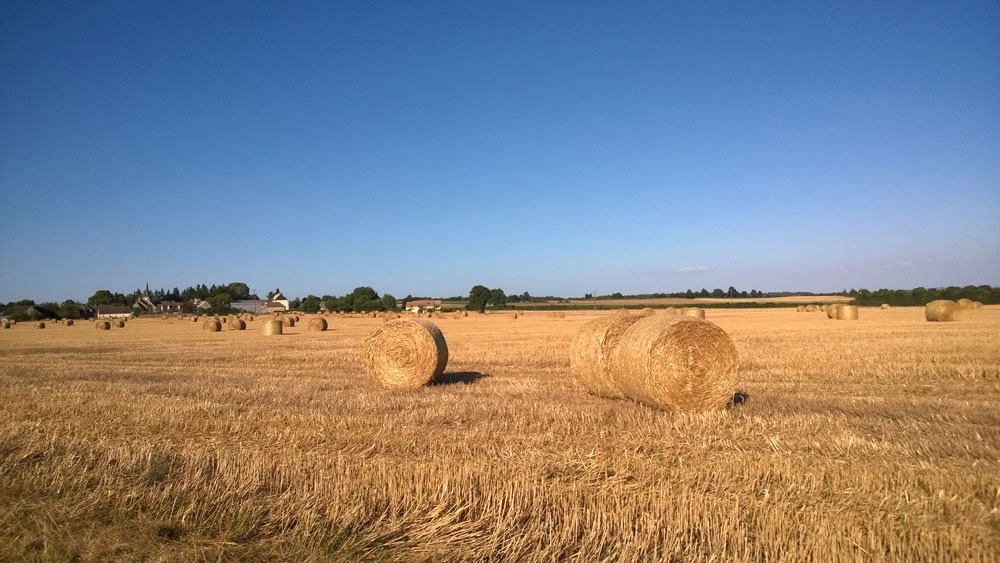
0,0,1000,302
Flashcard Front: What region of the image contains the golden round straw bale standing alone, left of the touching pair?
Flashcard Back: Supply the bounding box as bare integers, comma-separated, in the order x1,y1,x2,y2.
361,319,448,388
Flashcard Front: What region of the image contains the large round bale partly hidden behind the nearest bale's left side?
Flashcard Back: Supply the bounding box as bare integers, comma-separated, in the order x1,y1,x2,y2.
569,315,642,399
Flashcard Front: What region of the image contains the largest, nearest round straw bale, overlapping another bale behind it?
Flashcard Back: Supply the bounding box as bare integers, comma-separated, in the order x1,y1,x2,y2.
611,316,739,412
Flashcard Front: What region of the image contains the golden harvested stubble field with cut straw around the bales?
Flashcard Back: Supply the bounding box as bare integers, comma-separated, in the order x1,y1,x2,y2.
0,306,1000,562
